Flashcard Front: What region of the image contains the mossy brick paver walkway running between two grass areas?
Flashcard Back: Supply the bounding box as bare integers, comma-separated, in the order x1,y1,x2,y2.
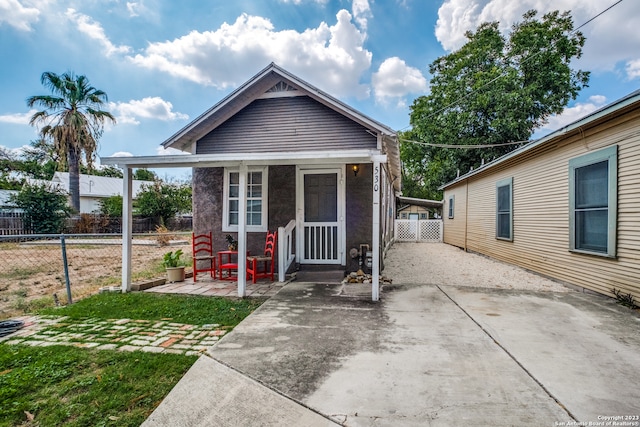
0,316,226,355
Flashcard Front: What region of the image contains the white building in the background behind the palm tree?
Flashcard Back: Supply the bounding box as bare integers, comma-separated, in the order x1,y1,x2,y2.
28,172,153,213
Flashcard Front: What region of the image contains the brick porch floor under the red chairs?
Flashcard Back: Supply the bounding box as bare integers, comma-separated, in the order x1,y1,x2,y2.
144,276,287,298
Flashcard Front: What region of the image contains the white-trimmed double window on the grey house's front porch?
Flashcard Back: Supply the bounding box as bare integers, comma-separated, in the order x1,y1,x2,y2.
222,167,269,231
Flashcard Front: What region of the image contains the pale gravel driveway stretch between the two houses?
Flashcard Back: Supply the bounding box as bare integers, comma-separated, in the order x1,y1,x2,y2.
382,243,570,292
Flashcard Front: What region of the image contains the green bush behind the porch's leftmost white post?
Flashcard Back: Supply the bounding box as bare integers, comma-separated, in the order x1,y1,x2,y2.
135,181,191,225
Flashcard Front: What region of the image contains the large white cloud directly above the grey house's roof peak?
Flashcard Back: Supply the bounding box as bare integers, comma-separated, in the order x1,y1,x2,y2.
130,10,372,98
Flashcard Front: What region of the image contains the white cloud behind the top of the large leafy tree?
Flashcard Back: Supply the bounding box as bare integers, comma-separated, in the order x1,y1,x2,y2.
435,0,640,71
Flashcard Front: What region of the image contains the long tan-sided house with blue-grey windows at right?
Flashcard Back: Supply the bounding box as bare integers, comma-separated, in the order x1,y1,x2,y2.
442,91,640,300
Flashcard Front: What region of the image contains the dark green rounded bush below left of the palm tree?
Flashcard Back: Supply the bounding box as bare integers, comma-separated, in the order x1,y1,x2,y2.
9,184,70,234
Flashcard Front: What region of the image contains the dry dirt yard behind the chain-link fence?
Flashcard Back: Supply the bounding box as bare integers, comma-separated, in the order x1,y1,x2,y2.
0,242,191,319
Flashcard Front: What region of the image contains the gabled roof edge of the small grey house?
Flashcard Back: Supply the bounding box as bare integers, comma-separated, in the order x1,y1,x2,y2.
162,63,401,190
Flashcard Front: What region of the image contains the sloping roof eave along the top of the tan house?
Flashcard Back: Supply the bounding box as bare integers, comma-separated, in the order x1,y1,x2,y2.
438,90,640,190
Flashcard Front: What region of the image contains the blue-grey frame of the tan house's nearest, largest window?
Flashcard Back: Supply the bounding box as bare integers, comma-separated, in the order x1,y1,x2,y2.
569,145,618,258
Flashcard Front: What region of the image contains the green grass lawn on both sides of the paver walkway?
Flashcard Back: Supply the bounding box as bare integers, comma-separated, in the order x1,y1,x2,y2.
0,293,264,427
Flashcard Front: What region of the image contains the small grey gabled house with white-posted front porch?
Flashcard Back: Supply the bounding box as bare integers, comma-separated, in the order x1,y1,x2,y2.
101,63,401,300
